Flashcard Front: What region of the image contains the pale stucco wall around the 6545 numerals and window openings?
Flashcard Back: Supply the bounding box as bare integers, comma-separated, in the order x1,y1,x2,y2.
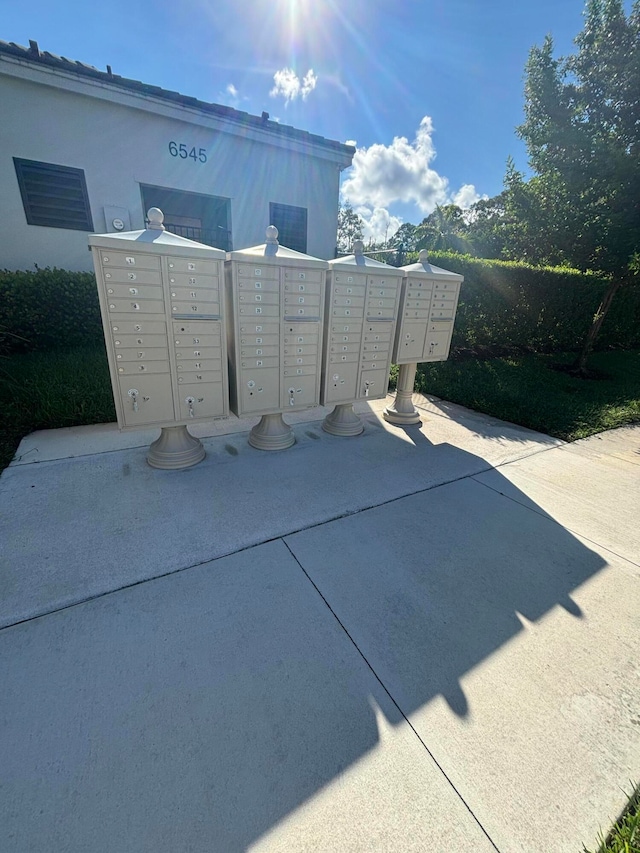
0,61,347,270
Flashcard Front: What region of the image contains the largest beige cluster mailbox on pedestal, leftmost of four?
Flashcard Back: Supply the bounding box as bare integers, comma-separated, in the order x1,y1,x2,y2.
89,208,229,468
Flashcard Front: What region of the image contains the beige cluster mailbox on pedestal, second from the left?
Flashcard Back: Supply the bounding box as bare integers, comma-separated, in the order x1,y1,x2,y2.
225,225,327,450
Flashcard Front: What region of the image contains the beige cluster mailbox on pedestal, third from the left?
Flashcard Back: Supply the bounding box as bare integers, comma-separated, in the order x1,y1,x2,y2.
320,240,402,435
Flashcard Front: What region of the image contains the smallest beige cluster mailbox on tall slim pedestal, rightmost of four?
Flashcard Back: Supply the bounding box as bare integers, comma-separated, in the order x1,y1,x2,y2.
384,249,464,424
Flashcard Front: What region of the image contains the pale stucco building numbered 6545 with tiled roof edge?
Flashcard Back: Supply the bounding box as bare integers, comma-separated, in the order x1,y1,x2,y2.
0,41,354,269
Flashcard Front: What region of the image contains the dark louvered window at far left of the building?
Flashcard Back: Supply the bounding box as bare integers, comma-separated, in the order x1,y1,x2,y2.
13,157,93,231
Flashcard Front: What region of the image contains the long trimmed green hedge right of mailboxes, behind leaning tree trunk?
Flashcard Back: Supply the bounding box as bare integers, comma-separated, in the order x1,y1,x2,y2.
422,252,640,352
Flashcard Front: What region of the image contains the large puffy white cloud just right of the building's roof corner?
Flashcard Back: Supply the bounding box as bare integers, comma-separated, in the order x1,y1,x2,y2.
341,116,479,217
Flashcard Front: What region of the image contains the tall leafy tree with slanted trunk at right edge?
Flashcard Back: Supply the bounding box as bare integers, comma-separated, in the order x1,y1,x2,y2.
507,0,640,374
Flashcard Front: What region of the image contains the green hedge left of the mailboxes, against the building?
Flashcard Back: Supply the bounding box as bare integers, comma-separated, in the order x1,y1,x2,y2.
0,267,103,354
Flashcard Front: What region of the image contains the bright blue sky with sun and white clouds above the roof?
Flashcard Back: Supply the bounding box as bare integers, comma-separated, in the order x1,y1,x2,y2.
0,0,616,240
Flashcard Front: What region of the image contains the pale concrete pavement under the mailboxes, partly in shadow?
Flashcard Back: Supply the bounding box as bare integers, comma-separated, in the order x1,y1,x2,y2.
0,398,640,853
